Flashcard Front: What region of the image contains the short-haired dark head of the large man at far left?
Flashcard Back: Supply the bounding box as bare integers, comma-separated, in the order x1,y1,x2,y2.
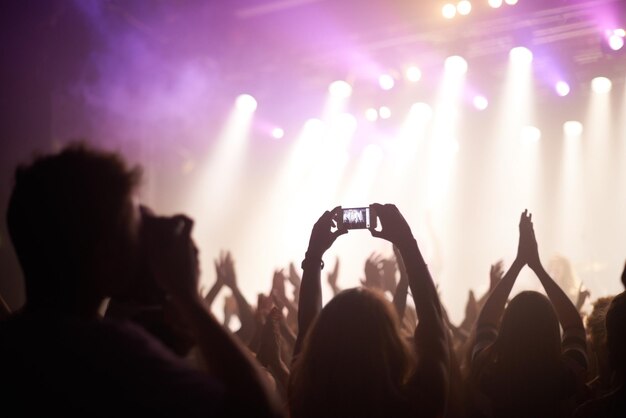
7,144,140,305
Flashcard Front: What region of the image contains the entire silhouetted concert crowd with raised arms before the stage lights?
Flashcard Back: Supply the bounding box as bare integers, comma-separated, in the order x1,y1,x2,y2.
0,144,626,418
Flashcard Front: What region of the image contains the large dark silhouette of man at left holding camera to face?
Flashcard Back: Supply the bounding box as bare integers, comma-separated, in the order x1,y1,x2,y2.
0,145,278,417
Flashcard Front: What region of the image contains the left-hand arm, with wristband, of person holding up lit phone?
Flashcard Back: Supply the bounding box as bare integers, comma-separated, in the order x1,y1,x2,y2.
293,206,348,358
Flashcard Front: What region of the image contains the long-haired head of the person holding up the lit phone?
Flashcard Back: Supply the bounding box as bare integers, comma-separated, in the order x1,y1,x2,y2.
289,289,414,417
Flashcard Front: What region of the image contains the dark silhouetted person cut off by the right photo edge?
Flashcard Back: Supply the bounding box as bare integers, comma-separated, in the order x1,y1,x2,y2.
575,292,626,418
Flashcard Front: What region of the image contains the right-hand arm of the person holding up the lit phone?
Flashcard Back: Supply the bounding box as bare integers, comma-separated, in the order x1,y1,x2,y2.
371,204,450,416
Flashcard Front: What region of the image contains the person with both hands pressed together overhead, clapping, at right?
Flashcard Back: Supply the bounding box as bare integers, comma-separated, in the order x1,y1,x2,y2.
471,211,587,418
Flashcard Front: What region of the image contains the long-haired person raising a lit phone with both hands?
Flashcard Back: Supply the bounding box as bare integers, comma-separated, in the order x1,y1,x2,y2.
289,204,449,418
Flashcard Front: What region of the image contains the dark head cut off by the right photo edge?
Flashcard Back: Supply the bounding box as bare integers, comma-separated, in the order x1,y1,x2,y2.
606,292,626,376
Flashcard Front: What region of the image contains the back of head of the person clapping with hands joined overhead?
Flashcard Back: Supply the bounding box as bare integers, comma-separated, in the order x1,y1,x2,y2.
496,291,561,372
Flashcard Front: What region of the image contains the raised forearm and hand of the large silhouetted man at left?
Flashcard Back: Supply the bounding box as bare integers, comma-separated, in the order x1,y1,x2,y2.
144,216,280,417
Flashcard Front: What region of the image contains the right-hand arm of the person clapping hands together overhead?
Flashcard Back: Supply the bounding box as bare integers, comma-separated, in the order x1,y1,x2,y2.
522,215,585,336
